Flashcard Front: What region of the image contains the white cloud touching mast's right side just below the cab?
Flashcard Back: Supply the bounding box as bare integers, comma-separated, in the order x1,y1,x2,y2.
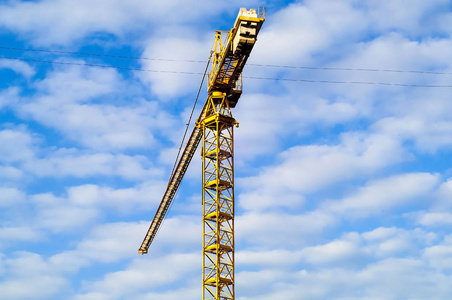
233,93,360,162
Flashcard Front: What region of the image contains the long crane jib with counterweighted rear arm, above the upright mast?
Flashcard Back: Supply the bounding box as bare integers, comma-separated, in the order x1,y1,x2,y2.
138,8,265,254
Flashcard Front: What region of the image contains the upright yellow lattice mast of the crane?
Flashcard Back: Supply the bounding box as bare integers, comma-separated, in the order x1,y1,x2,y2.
201,92,237,300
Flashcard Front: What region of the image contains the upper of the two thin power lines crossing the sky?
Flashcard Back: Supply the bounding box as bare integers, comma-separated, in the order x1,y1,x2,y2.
0,46,452,75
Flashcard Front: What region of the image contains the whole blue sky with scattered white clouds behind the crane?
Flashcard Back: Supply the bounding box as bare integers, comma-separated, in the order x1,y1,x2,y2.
0,0,452,300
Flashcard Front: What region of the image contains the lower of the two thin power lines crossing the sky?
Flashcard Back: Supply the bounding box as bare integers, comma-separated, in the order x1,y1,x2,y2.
0,56,452,88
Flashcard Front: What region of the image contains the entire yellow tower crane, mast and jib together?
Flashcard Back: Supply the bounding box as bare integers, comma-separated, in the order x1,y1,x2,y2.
138,7,265,300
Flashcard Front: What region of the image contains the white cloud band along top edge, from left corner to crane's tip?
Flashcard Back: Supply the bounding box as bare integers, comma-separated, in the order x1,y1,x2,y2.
0,0,255,46
